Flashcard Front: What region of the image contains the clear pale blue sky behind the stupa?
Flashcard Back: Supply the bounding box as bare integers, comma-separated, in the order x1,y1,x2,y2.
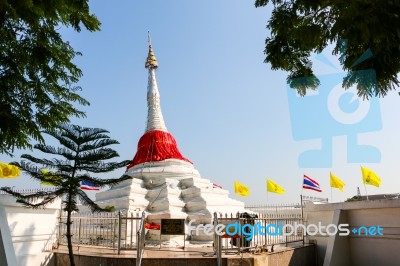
0,0,400,204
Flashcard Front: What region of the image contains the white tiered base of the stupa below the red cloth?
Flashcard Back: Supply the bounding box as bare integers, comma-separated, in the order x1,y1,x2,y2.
96,159,245,242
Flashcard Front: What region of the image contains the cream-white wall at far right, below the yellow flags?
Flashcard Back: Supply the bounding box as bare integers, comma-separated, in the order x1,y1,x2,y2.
304,199,400,266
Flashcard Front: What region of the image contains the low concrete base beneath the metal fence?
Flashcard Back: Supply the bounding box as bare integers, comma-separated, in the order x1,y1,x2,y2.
55,245,316,266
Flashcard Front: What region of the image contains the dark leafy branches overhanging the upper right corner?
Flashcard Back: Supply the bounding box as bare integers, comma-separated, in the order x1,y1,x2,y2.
255,0,400,98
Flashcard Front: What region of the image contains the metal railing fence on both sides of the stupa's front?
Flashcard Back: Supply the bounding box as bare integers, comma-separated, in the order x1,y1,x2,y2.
54,204,304,258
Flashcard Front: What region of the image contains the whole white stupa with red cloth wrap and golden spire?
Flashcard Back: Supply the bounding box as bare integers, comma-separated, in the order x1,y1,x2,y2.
96,34,244,241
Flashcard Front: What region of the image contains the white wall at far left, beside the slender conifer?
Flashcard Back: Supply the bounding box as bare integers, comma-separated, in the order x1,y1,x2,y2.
0,194,61,266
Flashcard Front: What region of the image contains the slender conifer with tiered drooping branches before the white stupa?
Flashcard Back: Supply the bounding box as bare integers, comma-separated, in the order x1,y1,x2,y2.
0,125,131,265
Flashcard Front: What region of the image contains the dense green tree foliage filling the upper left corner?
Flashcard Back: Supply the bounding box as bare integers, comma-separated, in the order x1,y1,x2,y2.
0,0,100,155
